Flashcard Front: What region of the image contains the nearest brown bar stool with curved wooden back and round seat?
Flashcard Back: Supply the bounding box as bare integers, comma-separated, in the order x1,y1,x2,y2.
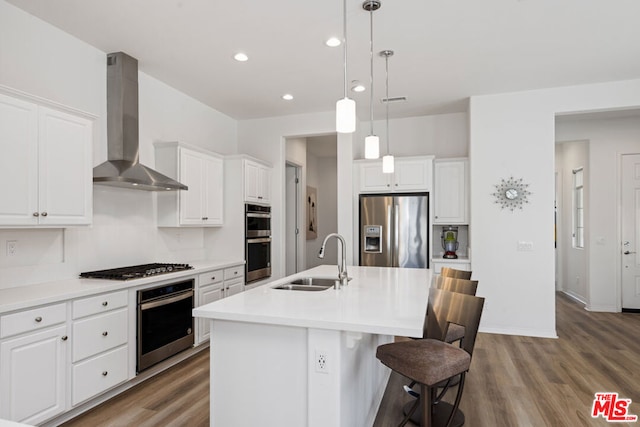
376,288,484,427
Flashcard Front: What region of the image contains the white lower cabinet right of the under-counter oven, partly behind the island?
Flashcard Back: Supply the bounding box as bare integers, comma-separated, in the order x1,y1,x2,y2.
196,264,245,344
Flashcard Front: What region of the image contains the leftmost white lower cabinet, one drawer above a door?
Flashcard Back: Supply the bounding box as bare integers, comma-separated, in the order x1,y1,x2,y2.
0,304,69,425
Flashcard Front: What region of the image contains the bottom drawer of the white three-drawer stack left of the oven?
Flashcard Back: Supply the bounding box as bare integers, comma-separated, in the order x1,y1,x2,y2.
71,346,128,406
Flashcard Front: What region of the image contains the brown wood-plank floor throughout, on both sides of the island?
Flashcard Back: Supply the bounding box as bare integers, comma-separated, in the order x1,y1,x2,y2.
64,294,640,427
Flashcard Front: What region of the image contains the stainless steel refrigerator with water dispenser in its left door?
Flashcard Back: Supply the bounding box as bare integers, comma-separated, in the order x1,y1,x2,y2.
360,193,429,268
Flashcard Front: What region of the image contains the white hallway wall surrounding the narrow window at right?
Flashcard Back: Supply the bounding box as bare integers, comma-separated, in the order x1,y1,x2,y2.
556,141,590,303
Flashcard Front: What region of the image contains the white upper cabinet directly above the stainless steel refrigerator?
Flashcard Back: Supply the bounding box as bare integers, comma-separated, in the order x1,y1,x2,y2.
359,157,433,193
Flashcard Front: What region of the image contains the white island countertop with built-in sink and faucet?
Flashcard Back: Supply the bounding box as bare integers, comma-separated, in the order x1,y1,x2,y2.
193,265,431,337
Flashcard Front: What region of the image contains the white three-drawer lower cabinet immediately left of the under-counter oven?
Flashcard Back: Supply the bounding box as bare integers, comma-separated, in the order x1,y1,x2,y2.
71,291,129,406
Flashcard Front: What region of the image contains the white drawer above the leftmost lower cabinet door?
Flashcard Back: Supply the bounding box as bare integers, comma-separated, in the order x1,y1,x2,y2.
0,303,67,338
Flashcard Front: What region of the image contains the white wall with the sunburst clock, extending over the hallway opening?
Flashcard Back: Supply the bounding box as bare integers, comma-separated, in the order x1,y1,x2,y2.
469,80,640,337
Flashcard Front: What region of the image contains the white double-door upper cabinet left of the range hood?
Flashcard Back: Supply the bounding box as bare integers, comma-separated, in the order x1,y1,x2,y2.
0,89,93,227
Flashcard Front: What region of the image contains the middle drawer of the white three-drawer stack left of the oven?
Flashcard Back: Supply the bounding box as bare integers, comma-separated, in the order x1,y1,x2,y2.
72,308,128,362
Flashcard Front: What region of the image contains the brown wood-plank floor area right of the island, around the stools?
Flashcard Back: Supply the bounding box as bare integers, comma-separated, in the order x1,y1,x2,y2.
374,294,640,427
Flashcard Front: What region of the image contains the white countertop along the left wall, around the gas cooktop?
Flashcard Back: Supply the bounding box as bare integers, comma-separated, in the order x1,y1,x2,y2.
0,260,244,314
